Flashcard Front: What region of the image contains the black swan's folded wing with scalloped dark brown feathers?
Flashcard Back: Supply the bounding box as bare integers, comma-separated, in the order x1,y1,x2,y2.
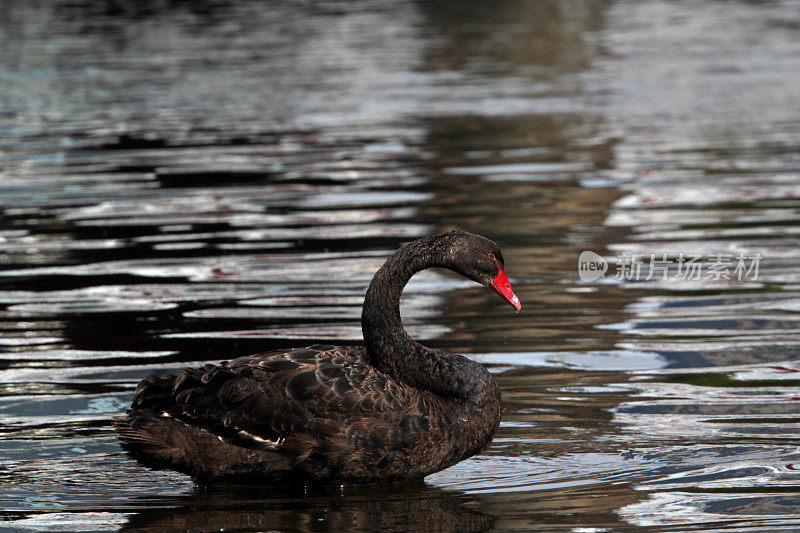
123,346,428,457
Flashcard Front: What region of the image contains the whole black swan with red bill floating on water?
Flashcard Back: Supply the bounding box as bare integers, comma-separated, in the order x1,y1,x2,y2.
114,231,521,483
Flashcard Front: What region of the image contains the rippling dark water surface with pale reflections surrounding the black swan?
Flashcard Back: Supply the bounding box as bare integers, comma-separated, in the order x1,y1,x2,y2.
0,1,800,532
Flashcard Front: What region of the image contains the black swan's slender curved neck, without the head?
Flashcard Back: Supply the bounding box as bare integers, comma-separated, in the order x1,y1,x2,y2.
361,234,491,400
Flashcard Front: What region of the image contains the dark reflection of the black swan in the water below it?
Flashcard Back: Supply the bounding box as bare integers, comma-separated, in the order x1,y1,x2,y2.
122,482,497,533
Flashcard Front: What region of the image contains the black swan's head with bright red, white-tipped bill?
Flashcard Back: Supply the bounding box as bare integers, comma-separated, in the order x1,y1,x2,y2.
442,231,522,311
